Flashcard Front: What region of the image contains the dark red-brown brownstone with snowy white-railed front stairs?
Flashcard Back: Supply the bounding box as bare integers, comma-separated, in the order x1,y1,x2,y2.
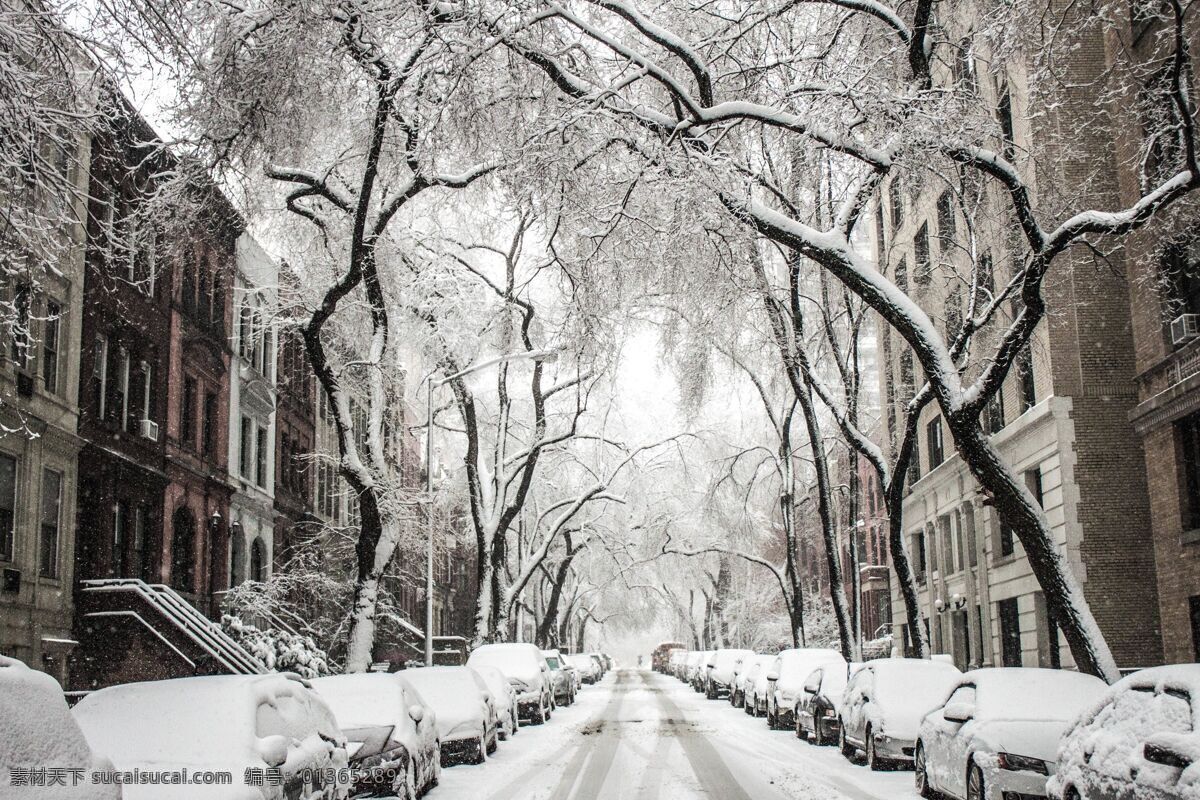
71,96,262,690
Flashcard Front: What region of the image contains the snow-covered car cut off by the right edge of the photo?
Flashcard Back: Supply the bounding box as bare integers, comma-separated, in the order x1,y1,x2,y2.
1046,663,1200,800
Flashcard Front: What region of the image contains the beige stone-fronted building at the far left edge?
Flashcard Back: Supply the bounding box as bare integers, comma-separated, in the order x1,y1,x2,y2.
0,92,91,682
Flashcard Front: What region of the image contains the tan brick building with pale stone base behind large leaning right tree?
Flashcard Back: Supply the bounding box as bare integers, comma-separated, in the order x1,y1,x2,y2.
875,14,1162,667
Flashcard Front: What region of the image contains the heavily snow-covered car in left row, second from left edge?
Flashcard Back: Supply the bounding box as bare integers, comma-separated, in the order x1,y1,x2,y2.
72,673,350,800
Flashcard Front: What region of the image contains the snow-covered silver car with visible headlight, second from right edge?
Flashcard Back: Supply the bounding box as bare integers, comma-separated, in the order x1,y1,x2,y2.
913,667,1108,800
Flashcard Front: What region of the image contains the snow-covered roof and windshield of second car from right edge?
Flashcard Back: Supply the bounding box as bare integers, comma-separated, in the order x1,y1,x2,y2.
959,667,1108,722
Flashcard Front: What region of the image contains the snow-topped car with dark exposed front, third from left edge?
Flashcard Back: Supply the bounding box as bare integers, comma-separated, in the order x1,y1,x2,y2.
310,673,442,798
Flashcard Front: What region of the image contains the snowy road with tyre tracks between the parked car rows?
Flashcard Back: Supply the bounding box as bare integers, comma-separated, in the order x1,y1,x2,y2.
428,669,917,800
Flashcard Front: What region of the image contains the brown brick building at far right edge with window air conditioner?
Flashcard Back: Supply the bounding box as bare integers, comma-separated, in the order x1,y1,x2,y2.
1109,14,1200,663
